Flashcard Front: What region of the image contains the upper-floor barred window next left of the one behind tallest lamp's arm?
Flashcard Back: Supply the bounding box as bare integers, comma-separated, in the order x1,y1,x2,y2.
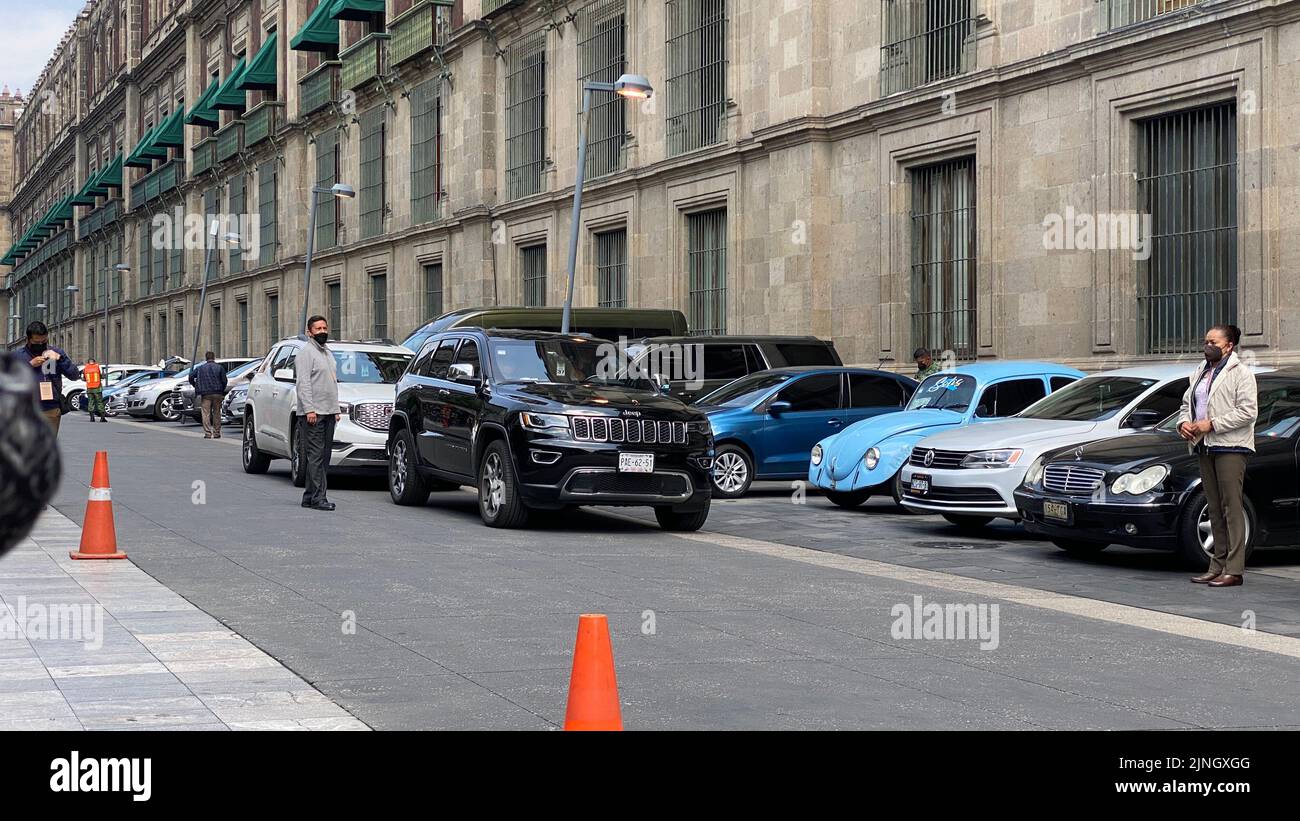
506,30,546,200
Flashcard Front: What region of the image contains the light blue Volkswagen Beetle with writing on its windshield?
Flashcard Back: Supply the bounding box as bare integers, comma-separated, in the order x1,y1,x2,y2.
809,361,1083,508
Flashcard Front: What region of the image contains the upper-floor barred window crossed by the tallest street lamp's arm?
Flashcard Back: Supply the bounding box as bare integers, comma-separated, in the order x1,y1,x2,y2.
577,0,628,177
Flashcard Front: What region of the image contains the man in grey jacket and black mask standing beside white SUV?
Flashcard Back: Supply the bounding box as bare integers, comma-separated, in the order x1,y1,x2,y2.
294,316,338,511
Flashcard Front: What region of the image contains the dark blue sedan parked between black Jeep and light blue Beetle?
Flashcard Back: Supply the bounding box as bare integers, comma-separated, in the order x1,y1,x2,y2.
696,366,917,499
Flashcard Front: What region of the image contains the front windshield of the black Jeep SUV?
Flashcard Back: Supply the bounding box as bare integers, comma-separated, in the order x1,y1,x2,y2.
488,339,655,391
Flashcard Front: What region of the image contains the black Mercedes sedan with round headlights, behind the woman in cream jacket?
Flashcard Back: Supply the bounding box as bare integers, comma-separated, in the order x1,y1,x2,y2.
1015,369,1300,570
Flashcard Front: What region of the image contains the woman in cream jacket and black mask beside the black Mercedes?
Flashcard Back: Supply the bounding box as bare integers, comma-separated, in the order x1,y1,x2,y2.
1178,325,1260,587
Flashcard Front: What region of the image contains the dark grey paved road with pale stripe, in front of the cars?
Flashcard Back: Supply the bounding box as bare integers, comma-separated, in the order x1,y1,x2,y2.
45,414,1300,729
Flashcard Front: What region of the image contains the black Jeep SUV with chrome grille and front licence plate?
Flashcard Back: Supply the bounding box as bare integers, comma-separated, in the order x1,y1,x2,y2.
389,327,714,530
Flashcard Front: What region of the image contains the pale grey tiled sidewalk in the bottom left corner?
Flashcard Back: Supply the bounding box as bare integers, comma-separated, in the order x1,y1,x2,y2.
0,508,369,731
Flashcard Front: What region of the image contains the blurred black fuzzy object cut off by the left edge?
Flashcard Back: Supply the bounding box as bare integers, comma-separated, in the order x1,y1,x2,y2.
0,356,62,556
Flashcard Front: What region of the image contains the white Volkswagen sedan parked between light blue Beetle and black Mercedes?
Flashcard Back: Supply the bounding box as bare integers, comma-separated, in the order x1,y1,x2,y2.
901,362,1196,530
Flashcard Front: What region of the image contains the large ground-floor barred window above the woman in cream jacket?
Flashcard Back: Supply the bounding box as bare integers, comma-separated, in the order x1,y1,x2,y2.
1138,103,1238,355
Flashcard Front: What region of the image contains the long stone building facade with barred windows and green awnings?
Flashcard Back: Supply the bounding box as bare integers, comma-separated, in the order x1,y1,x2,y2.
0,0,1300,369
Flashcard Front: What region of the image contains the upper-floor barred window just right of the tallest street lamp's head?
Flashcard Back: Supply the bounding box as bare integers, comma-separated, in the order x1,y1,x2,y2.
667,0,728,157
